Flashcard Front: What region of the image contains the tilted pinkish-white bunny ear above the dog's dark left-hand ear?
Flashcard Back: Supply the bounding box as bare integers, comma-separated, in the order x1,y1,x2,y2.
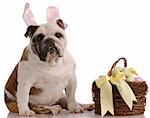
23,3,37,26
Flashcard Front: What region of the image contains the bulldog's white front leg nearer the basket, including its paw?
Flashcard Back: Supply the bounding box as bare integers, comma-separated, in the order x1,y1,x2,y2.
65,78,84,113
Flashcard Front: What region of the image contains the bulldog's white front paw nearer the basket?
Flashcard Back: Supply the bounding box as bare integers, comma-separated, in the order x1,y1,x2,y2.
68,103,84,113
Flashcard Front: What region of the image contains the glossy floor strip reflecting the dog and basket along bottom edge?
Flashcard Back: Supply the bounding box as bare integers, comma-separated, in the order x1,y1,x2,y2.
7,111,148,118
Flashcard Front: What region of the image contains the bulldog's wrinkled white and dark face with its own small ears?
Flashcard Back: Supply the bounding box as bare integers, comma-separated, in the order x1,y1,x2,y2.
25,19,67,62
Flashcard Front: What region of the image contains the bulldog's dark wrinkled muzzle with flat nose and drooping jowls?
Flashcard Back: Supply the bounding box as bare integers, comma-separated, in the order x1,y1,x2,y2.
31,38,64,62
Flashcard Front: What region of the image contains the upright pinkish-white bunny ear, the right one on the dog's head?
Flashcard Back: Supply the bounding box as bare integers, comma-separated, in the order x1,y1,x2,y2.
47,6,60,22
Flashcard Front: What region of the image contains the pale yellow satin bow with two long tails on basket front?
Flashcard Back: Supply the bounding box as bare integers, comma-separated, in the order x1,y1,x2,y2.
95,71,137,116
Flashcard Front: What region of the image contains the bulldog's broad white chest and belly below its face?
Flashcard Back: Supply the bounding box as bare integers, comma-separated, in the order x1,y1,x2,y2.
18,50,75,104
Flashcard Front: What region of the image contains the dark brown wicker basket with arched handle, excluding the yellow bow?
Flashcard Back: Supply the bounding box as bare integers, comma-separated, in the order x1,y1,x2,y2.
92,58,148,116
